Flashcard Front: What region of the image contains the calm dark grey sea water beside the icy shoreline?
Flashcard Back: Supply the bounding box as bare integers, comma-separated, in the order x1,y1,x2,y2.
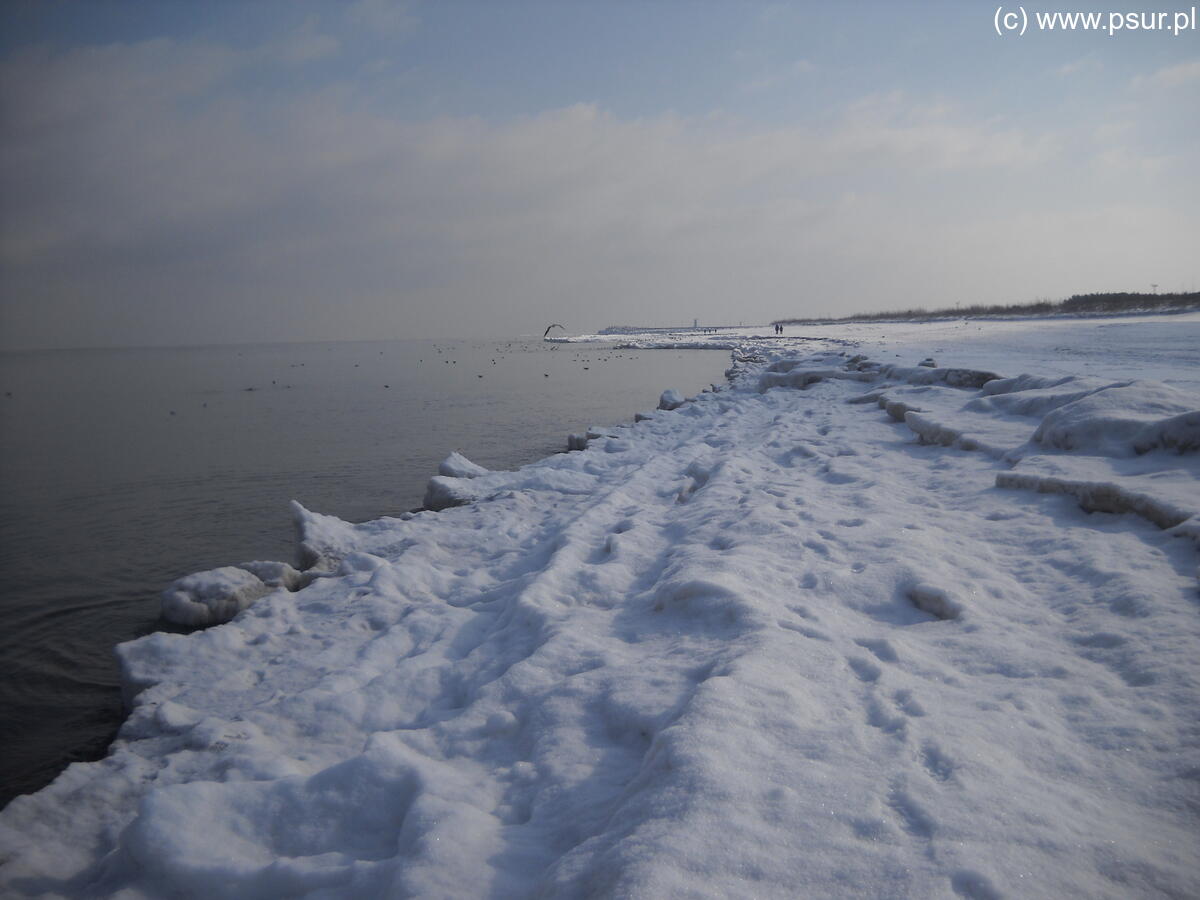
0,341,728,805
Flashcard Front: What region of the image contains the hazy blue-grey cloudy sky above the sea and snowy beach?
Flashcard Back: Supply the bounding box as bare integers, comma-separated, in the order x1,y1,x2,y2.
0,0,1200,349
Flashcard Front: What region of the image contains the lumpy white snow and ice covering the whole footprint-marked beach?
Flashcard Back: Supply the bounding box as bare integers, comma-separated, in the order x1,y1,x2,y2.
0,316,1200,898
